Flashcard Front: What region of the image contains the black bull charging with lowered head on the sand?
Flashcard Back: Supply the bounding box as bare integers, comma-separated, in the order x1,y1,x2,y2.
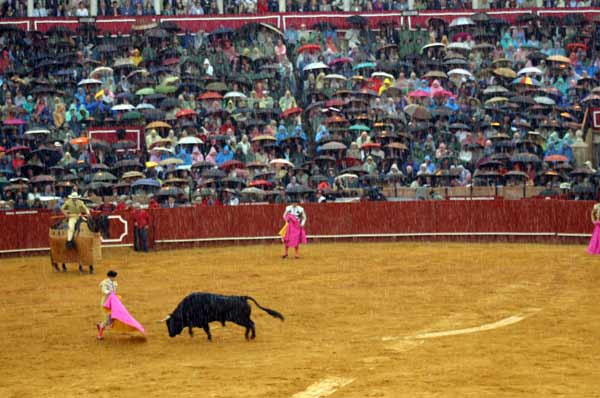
165,293,283,340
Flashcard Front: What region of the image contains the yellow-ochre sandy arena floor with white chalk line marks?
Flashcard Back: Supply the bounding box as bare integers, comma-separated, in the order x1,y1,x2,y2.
0,243,600,398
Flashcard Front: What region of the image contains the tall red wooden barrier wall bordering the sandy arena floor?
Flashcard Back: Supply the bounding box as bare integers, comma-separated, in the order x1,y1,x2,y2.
0,200,594,254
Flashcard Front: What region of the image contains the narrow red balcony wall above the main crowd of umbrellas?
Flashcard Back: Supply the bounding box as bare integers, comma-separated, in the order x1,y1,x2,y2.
0,8,600,34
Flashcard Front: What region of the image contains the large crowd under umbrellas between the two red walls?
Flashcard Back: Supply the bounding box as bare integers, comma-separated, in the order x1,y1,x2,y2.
0,13,600,208
